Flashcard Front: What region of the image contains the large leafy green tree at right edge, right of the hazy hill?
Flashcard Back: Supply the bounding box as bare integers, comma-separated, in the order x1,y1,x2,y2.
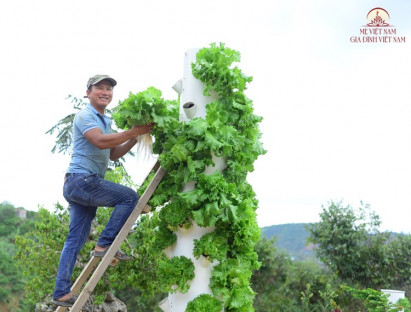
308,202,411,289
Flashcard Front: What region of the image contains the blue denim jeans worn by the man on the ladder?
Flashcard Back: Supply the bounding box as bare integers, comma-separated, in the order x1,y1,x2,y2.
53,173,139,299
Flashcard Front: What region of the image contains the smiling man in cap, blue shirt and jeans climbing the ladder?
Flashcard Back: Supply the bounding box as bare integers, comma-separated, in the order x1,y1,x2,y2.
53,75,153,307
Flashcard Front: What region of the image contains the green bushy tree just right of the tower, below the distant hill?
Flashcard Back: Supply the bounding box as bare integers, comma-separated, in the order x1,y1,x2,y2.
252,237,339,312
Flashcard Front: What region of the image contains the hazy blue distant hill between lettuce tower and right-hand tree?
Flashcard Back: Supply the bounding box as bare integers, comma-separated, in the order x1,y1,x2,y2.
261,223,315,260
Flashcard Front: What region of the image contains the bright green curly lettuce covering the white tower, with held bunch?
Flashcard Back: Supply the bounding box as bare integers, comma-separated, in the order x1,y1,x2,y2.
113,43,266,312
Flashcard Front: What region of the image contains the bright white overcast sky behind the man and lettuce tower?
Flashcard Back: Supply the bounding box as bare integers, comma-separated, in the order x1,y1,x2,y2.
0,0,411,233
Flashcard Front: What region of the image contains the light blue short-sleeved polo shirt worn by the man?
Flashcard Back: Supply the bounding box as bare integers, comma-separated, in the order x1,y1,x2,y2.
67,103,112,178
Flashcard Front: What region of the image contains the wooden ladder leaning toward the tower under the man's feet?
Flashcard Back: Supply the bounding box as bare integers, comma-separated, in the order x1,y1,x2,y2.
55,162,165,312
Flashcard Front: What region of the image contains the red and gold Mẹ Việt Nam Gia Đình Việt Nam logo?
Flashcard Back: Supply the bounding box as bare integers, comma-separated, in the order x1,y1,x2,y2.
350,8,406,43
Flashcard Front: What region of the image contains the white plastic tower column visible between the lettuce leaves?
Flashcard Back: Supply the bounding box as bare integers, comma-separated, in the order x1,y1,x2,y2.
159,49,226,312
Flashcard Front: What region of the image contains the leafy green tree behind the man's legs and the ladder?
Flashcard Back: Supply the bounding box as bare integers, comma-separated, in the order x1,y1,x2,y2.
16,167,166,311
